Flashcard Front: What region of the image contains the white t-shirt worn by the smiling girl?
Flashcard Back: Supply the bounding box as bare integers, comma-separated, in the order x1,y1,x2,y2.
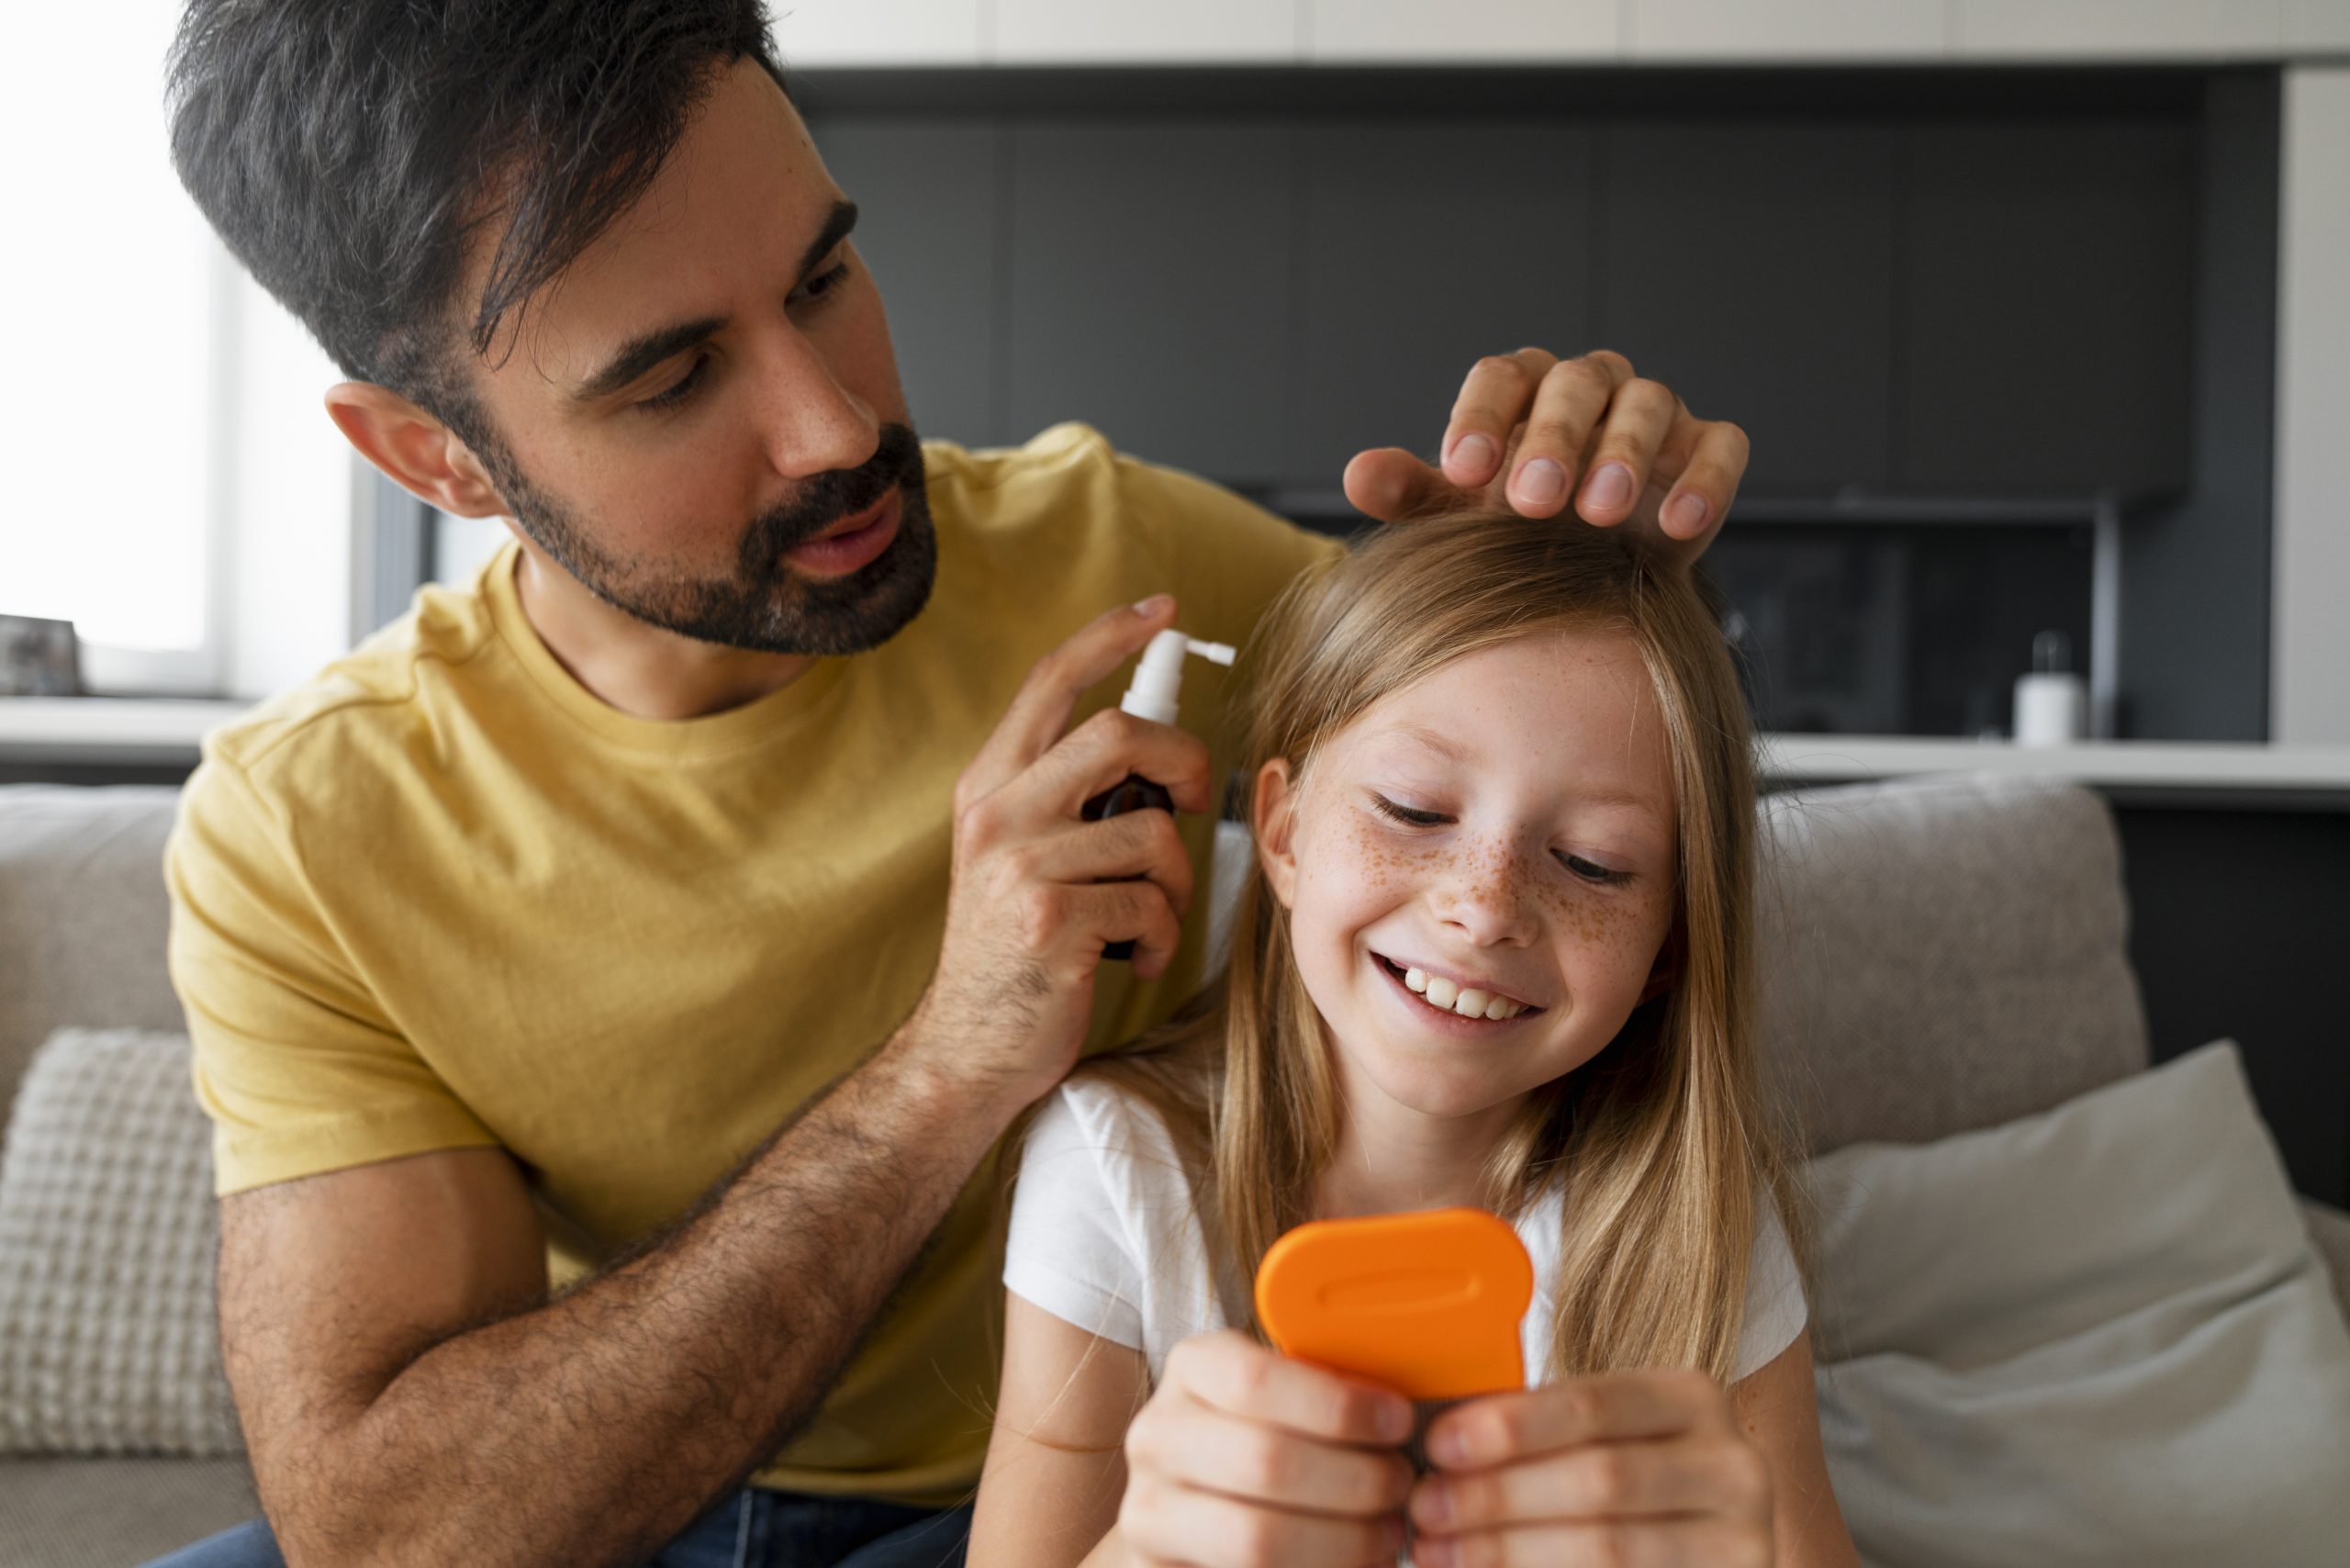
1003,1081,1809,1384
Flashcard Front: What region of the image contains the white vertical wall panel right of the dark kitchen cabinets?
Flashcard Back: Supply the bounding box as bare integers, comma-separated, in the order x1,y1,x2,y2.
2270,66,2350,745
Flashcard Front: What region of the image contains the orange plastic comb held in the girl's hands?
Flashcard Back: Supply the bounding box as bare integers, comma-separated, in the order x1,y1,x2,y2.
1258,1208,1535,1399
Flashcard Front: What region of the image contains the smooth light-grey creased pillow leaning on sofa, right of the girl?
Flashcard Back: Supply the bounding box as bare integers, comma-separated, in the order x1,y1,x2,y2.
1809,1041,2350,1568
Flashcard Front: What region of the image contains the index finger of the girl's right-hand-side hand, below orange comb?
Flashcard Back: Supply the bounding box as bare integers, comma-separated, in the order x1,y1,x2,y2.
1427,1368,1729,1469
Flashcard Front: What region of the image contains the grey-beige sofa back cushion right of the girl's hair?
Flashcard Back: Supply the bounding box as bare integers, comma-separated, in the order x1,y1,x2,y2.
1758,776,2148,1152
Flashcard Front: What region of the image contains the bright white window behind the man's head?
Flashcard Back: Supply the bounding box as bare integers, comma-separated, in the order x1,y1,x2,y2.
0,0,352,696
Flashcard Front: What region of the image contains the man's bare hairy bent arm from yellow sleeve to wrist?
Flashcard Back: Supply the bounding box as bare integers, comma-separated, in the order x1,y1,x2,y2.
221,1035,1011,1568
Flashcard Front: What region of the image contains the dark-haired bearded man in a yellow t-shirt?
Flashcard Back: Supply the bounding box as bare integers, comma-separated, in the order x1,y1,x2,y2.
151,0,1744,1568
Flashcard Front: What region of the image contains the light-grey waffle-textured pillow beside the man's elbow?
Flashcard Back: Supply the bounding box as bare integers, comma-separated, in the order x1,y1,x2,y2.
0,1030,242,1458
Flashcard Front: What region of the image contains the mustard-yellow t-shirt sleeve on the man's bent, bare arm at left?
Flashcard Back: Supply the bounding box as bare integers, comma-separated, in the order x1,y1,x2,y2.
164,755,498,1196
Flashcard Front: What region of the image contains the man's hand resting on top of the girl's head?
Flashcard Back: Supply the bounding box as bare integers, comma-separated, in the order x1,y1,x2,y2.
1347,348,1746,559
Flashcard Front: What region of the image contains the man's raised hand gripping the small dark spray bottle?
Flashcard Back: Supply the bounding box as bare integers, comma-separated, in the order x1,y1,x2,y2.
902,595,1213,1107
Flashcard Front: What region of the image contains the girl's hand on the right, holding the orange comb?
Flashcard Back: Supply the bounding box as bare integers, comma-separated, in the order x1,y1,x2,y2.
1413,1371,1772,1568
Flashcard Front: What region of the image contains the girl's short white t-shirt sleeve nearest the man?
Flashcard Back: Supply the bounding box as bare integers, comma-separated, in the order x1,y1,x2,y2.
1003,1089,1145,1350
